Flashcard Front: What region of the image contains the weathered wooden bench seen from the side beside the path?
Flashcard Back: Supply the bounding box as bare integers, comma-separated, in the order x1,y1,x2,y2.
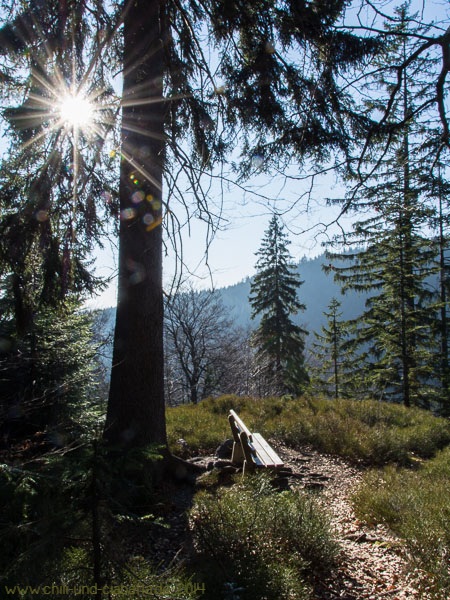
228,410,284,474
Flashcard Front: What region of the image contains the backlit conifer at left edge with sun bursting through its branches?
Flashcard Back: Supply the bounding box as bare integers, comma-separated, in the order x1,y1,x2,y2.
0,1,114,446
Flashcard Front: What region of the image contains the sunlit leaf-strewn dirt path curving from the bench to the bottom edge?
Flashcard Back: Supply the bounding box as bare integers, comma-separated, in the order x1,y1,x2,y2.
277,447,432,600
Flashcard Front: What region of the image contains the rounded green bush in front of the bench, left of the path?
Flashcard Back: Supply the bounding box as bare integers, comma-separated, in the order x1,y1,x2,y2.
191,474,337,600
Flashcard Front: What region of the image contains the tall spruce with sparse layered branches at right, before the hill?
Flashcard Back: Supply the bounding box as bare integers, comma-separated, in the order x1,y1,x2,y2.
328,131,437,406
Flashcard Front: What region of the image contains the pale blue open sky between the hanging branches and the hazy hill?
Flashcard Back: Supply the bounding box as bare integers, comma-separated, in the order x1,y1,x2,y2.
85,163,348,308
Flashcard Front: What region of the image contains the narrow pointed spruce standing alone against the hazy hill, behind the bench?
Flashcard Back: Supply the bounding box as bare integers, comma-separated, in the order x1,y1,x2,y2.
250,214,308,394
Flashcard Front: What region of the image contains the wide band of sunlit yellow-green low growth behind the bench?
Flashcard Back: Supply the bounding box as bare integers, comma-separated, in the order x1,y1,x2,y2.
167,396,450,465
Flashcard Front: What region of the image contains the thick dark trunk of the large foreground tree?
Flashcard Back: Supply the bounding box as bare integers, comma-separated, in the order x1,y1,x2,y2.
105,0,166,446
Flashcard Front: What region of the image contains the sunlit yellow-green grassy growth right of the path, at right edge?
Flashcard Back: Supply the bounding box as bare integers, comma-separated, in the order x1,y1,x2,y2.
353,448,450,598
